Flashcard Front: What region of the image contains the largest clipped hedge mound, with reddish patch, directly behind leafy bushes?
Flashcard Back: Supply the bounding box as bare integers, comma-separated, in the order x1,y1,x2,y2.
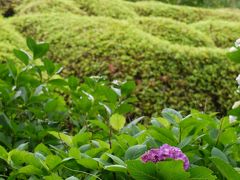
11,14,239,115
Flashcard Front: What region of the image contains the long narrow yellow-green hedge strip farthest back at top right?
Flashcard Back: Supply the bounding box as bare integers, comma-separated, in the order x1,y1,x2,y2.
126,1,240,23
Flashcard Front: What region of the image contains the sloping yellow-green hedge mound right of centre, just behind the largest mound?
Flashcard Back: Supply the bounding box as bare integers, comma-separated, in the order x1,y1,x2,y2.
128,17,214,47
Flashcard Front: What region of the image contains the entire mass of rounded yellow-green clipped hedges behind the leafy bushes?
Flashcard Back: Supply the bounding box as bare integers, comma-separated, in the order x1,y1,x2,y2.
0,0,240,115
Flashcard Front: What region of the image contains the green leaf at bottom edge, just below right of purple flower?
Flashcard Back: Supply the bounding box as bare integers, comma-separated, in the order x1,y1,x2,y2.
189,166,217,180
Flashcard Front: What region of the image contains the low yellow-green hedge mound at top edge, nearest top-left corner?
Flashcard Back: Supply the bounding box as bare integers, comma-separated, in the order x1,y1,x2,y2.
16,0,86,15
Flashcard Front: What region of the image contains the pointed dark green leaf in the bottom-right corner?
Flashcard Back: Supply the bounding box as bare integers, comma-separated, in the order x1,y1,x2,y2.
210,157,240,180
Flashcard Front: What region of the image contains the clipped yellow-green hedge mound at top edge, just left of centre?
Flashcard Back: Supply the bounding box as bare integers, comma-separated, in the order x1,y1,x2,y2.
74,0,136,18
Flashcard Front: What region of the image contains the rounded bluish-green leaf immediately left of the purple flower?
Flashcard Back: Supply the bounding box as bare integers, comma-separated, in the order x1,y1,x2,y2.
124,145,147,160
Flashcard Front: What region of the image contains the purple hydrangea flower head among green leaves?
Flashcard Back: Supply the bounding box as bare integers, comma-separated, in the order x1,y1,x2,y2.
141,144,190,170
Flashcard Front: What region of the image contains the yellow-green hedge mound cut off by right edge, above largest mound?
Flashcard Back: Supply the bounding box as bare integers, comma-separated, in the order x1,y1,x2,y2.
193,21,240,48
